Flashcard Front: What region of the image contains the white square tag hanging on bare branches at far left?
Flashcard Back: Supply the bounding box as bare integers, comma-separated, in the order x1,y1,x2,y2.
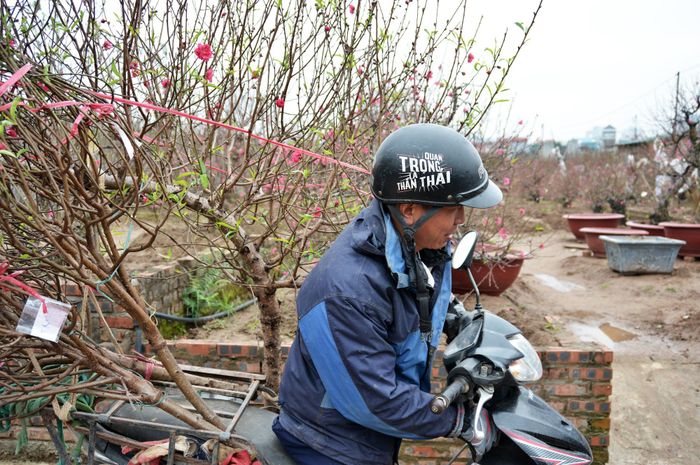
17,297,70,342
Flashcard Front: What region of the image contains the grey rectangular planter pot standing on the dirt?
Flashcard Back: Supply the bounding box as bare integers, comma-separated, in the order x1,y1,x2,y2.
600,235,685,274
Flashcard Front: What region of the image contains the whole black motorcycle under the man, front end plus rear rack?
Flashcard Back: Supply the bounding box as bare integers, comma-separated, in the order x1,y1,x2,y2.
74,231,592,465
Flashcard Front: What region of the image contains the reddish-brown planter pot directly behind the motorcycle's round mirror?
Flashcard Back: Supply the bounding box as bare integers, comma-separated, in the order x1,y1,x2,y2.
452,256,525,296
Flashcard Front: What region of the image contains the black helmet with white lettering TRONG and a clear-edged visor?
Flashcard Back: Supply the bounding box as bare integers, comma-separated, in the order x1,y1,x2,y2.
372,124,503,208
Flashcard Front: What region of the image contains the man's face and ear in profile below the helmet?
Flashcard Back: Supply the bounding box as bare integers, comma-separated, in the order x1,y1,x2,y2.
407,204,464,251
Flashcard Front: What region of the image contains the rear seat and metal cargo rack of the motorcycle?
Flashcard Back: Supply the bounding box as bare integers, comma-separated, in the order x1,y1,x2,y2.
71,365,295,465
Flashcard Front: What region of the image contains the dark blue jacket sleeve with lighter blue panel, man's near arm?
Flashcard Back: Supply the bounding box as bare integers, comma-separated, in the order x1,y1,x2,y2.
299,297,457,439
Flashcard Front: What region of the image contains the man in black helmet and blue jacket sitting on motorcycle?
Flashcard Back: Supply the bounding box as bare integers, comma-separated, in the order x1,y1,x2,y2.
273,124,502,465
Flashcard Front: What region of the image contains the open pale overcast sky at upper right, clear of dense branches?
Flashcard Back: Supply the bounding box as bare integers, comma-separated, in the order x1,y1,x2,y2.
468,0,700,141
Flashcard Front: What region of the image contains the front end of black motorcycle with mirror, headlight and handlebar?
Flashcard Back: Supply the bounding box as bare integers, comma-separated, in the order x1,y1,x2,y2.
430,231,593,465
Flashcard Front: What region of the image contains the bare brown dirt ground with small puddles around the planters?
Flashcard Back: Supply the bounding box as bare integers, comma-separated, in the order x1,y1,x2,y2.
194,231,700,465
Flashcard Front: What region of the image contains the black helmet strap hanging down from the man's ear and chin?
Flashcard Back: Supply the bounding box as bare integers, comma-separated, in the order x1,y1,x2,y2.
386,204,440,343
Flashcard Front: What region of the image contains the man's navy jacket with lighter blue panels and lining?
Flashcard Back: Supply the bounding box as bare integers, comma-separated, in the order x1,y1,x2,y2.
279,200,457,465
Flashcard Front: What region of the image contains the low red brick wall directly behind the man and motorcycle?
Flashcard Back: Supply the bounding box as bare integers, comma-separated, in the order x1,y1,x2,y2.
164,340,613,465
